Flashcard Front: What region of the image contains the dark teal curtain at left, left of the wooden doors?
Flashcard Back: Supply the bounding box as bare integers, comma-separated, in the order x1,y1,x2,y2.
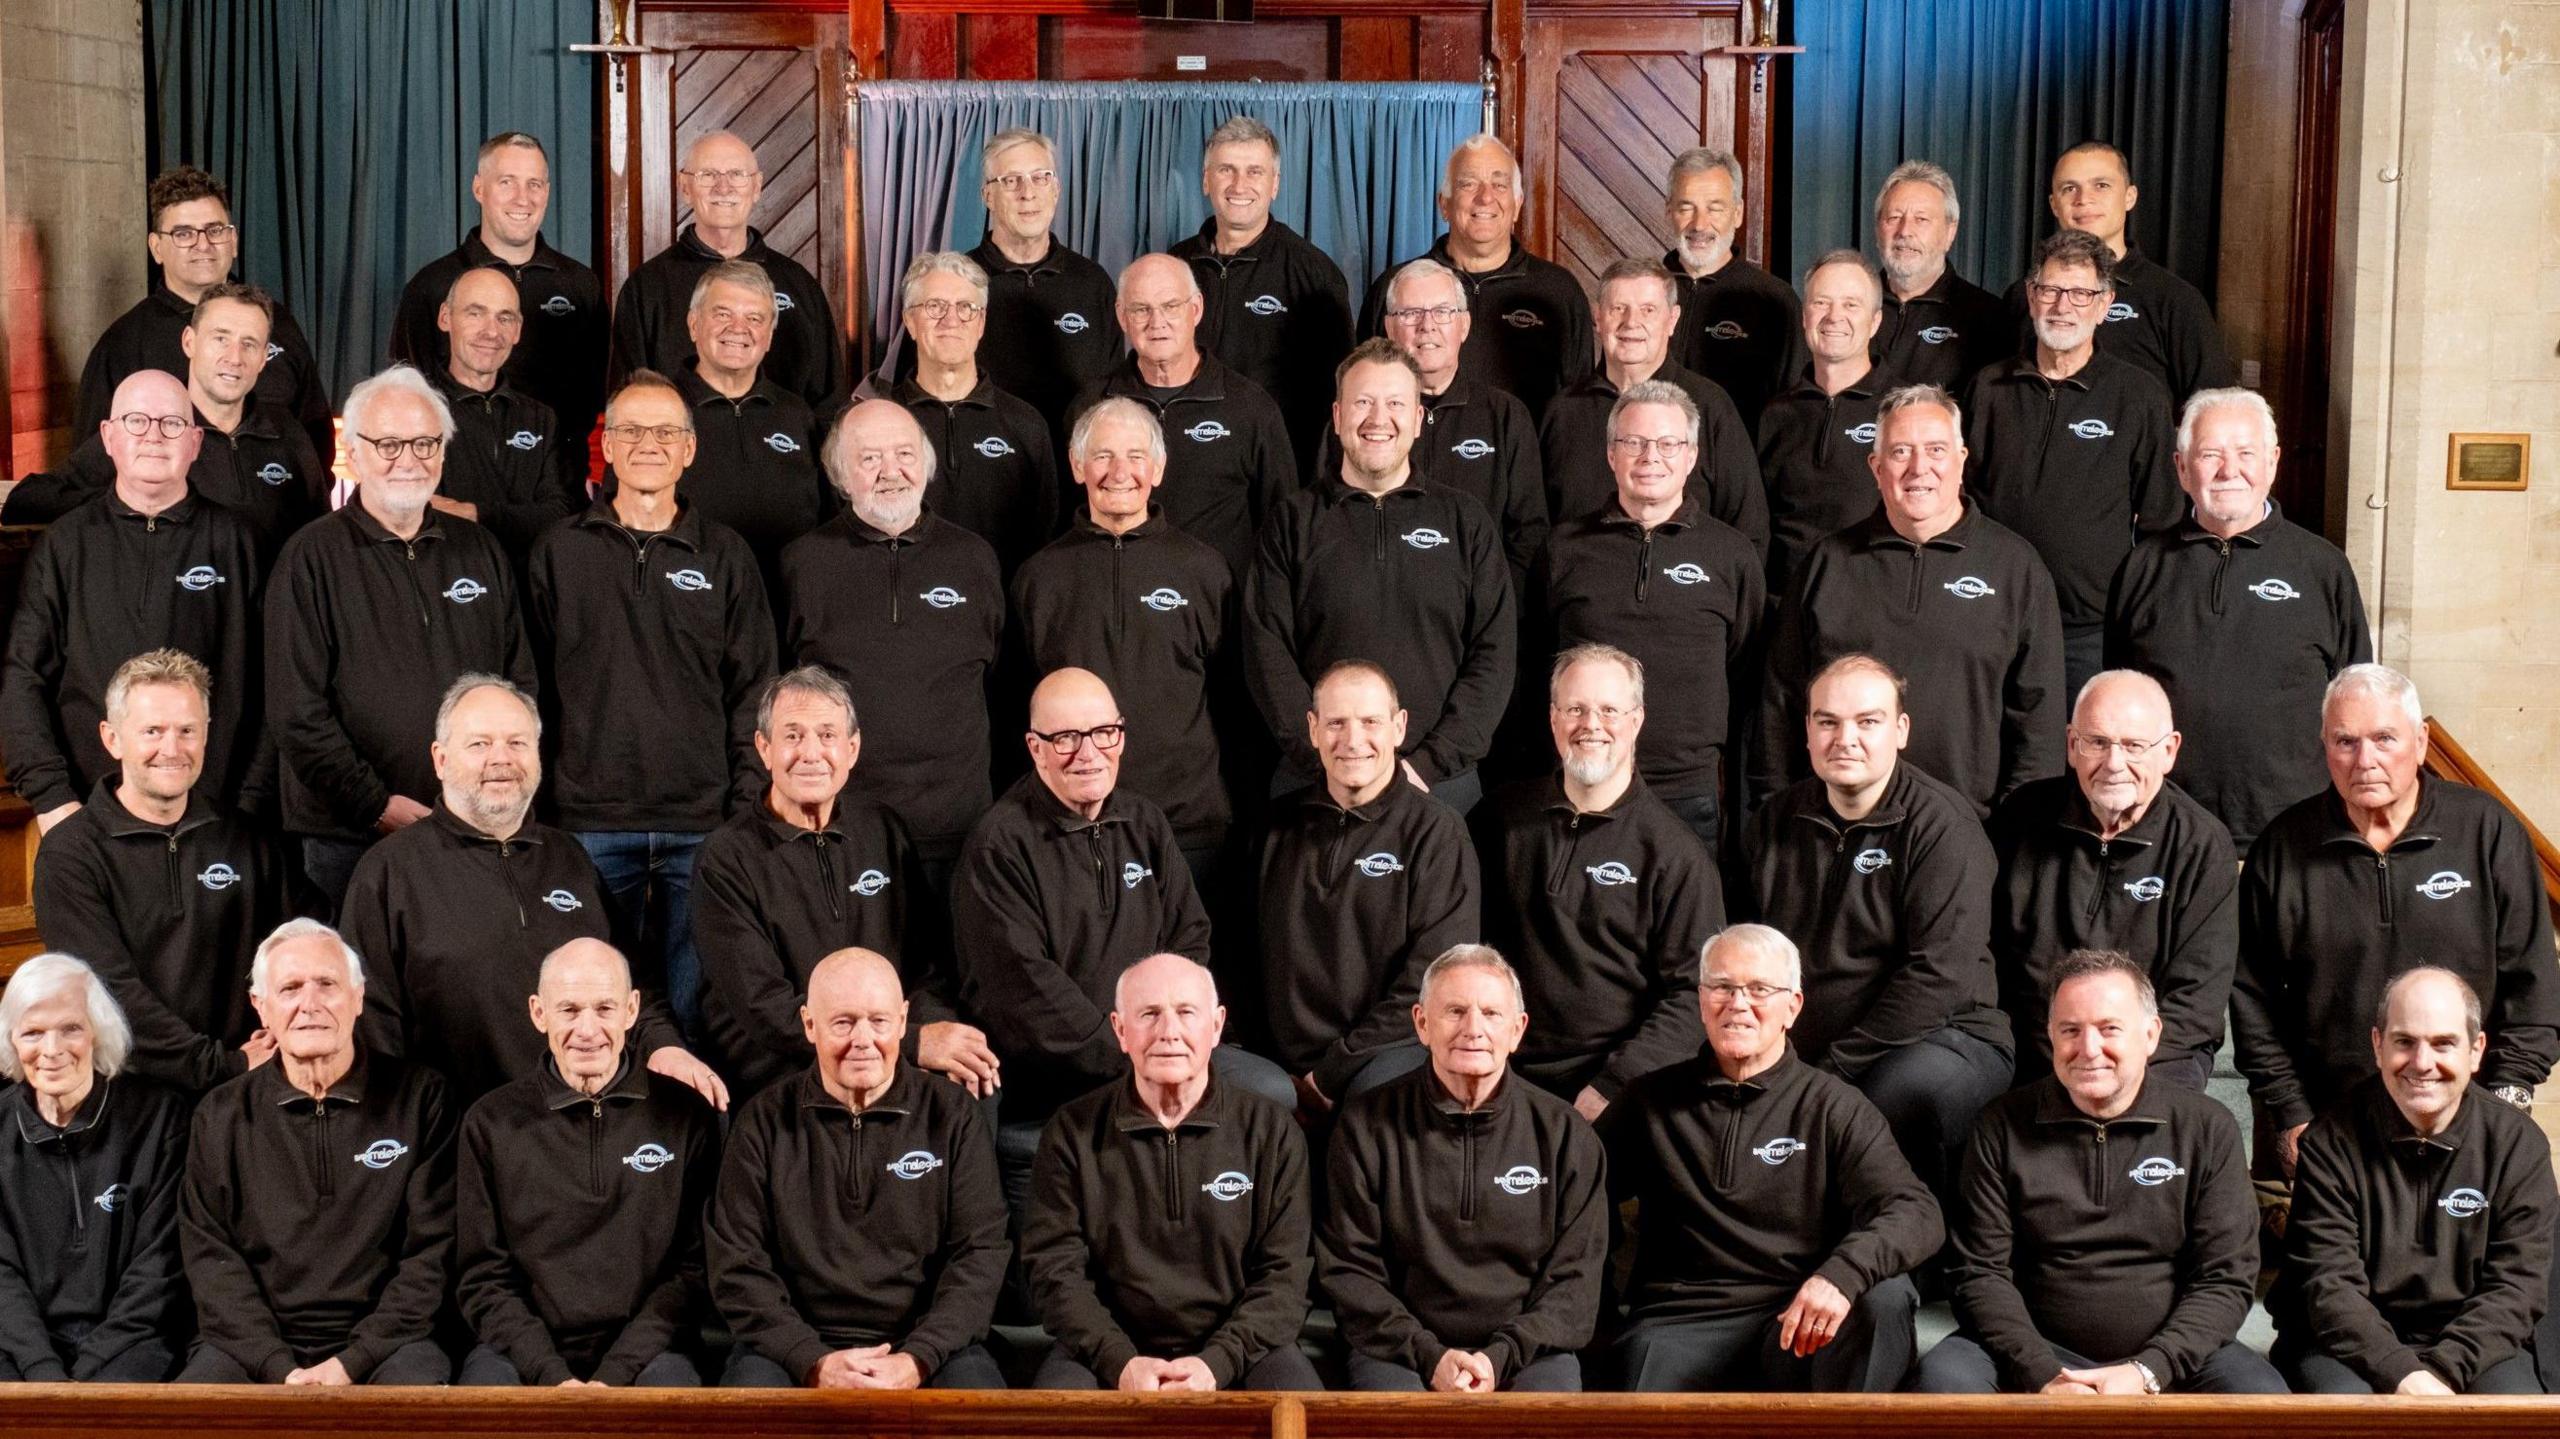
143,0,596,397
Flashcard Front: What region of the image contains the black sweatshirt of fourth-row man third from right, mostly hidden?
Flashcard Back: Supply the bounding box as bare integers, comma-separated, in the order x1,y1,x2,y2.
1539,361,1769,553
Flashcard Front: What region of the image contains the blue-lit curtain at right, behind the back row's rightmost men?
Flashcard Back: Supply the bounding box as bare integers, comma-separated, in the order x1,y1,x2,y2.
1789,0,2230,297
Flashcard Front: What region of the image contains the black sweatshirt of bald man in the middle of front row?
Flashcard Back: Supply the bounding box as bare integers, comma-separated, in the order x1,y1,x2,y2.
1021,1075,1316,1388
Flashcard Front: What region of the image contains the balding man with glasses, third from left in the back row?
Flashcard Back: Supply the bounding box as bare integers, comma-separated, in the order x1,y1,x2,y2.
607,131,845,410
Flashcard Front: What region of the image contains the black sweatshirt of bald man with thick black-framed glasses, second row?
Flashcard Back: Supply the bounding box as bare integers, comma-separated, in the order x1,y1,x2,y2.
952,773,1208,1104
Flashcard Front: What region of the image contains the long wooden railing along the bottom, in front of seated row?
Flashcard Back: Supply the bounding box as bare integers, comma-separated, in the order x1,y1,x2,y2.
0,1385,2560,1439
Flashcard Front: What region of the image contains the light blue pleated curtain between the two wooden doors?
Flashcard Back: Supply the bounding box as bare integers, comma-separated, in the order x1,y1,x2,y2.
858,79,1485,343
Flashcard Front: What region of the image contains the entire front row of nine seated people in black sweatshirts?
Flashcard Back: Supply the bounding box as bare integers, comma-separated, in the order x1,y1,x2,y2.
0,919,2560,1395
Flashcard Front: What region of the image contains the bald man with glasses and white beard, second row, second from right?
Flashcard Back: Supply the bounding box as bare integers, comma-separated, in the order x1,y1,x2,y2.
1989,671,2240,1093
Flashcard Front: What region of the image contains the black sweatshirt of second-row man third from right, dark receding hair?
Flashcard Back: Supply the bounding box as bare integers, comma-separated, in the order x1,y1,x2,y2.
1743,763,2010,1081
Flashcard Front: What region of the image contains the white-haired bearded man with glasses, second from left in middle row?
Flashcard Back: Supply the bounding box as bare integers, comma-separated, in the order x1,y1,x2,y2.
266,366,532,904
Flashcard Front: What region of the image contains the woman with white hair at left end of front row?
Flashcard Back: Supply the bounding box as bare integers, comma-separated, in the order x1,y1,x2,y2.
0,955,187,1383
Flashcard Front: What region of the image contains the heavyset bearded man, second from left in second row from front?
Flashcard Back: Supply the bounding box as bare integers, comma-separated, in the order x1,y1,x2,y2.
340,676,727,1106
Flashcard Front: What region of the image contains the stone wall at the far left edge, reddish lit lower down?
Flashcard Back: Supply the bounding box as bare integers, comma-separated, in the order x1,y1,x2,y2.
0,0,148,479
